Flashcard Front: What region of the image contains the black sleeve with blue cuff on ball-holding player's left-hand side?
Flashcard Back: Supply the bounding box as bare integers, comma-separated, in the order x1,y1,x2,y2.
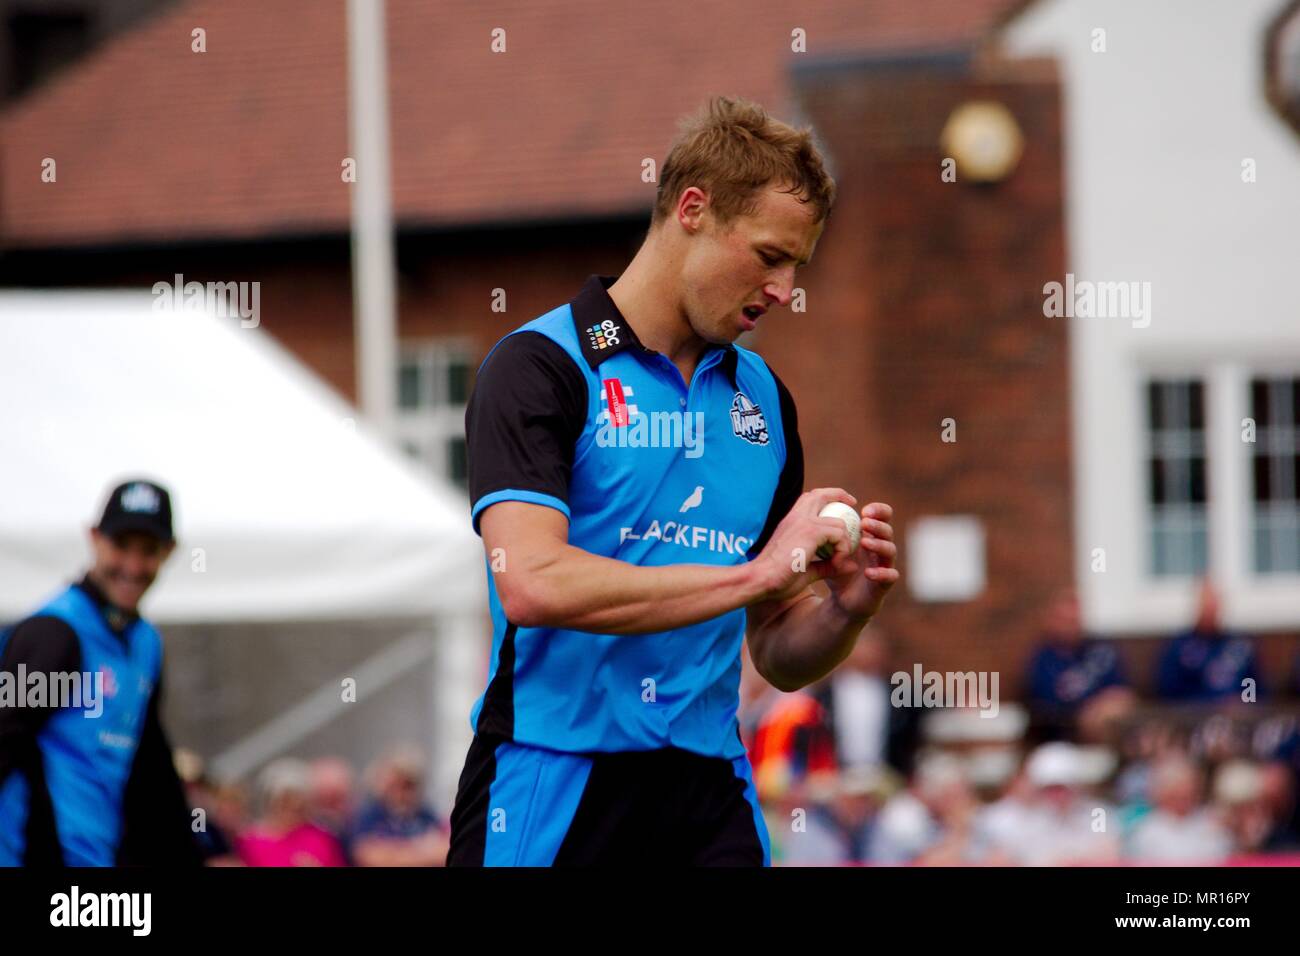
465,332,588,532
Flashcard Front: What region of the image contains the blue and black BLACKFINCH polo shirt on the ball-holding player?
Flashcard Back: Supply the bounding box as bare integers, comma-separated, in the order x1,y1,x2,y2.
465,276,803,758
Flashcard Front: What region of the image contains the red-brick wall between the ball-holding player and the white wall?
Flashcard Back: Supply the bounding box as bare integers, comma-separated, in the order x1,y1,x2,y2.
780,62,1074,693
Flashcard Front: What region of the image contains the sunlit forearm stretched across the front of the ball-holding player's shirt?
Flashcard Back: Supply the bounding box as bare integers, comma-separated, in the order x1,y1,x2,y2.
495,545,766,635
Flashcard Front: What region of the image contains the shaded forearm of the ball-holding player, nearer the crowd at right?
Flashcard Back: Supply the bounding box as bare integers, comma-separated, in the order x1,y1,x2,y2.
750,592,867,691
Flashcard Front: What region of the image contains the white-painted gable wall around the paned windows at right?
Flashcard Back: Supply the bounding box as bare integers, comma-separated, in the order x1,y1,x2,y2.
1004,0,1300,631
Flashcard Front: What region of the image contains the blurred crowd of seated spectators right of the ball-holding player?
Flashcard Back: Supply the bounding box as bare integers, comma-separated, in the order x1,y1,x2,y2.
741,583,1300,865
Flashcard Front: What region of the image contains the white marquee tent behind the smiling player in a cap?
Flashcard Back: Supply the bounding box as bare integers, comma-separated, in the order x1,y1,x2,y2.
0,291,485,806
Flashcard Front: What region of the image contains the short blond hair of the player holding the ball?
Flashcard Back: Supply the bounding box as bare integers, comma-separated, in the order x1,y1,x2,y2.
650,96,835,226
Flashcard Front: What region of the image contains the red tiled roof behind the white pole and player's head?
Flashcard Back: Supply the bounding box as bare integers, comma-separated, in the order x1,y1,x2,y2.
0,0,1018,247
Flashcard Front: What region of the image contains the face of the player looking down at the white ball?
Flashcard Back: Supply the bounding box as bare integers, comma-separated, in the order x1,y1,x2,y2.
681,186,824,345
